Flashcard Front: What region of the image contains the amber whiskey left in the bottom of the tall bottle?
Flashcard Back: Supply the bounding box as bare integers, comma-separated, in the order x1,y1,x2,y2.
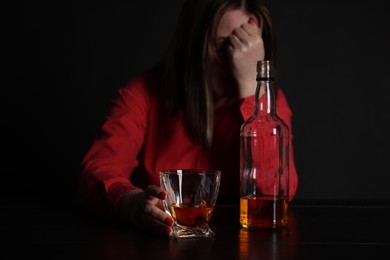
240,195,288,229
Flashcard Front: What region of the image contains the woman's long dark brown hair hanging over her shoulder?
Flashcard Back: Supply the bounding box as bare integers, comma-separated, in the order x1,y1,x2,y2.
161,0,276,149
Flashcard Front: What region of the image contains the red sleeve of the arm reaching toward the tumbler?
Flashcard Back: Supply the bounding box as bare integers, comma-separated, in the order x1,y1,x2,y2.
79,74,150,217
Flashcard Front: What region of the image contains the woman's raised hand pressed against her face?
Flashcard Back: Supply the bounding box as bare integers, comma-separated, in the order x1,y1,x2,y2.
227,18,264,98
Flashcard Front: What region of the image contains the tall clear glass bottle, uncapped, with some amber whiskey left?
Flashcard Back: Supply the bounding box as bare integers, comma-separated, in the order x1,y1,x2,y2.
240,60,289,229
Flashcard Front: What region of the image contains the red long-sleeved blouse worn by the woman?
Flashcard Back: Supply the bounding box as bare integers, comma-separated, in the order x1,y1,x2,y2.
79,74,298,217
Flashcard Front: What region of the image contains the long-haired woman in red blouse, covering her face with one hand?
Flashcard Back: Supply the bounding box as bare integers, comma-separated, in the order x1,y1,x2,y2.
80,0,298,236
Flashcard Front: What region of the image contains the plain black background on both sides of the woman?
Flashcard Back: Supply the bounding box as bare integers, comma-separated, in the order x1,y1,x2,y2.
0,0,390,206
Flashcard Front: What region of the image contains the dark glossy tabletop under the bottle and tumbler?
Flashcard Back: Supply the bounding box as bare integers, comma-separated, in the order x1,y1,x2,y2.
0,199,390,259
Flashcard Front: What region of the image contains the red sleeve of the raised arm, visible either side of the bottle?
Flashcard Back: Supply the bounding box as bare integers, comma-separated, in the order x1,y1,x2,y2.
240,88,298,201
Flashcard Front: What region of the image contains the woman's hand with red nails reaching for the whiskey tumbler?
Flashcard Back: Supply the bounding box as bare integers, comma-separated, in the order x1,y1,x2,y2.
120,185,173,236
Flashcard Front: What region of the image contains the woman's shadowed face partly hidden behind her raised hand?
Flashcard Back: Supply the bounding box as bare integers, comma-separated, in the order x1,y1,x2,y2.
210,10,253,96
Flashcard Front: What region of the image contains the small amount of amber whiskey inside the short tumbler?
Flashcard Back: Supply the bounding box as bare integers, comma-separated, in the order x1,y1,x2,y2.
169,205,214,228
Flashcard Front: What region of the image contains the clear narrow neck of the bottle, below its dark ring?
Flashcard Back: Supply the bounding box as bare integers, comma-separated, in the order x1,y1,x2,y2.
254,78,275,116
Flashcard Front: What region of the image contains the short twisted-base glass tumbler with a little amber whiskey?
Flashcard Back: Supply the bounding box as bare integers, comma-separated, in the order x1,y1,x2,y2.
160,169,221,238
